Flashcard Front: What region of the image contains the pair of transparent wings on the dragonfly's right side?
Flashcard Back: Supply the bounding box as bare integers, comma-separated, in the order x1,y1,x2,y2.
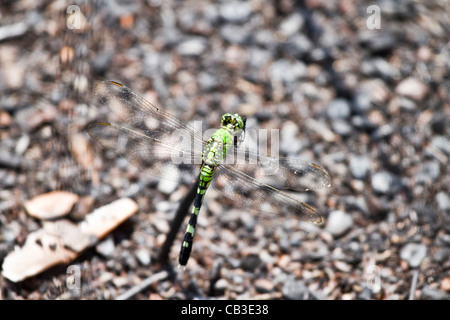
214,152,330,223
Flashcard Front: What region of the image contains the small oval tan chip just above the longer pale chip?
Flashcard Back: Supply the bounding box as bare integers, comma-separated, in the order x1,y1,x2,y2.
24,191,78,220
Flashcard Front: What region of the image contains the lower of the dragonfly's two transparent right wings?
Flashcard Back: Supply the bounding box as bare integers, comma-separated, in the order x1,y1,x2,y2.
214,164,322,223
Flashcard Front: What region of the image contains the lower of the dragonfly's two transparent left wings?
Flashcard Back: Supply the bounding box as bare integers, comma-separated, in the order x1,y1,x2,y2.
86,122,201,183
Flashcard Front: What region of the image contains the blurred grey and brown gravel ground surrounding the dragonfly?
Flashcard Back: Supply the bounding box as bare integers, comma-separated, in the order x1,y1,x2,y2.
0,0,450,300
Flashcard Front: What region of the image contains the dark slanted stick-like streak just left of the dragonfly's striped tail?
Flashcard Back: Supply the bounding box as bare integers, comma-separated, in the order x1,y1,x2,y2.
158,179,200,265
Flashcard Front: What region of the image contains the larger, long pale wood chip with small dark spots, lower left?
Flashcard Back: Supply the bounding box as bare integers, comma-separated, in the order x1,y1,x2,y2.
2,198,138,282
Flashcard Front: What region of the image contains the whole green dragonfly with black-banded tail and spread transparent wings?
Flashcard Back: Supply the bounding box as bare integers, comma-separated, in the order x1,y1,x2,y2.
87,81,331,268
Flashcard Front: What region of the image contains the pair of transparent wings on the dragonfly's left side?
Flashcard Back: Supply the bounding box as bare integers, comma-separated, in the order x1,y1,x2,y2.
87,81,204,182
